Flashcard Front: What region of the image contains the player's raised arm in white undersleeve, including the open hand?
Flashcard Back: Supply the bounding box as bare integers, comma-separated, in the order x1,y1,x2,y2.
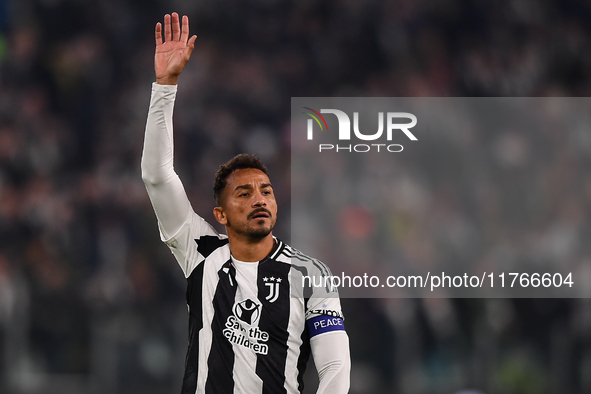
141,13,196,239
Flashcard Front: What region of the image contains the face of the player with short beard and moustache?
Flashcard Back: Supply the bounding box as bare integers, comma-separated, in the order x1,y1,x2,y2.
214,168,277,240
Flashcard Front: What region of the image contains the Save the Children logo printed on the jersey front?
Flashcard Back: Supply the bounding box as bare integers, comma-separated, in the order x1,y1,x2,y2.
223,298,269,354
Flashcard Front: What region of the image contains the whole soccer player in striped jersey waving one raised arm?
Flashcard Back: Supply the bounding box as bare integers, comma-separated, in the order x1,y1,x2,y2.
142,13,351,394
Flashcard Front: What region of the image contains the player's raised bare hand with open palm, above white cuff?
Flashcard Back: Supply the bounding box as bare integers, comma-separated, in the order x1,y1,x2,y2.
154,12,197,85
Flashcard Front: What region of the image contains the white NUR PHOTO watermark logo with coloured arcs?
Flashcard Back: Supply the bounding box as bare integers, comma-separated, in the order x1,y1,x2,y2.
303,107,417,152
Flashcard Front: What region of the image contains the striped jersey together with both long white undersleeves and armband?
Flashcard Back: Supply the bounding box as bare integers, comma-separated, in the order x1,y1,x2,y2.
141,83,351,394
